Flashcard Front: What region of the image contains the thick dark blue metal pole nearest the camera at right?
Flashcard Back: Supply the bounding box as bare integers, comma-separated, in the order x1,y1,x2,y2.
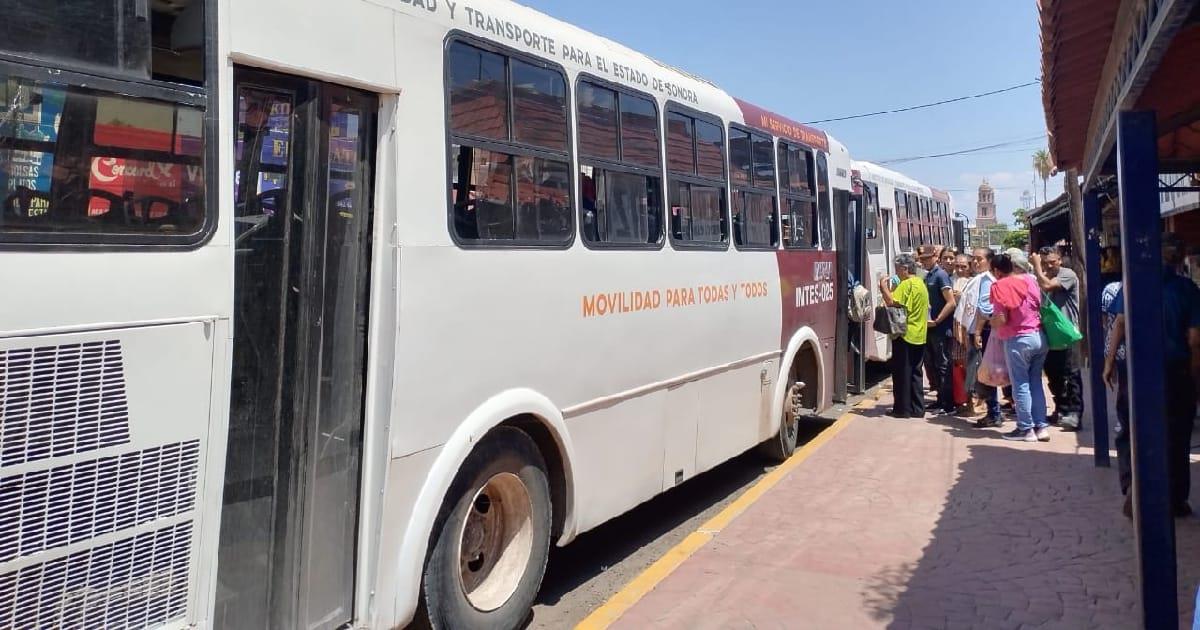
1117,112,1178,629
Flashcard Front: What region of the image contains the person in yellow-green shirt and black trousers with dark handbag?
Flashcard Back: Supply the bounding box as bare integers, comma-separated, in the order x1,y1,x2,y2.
880,254,929,418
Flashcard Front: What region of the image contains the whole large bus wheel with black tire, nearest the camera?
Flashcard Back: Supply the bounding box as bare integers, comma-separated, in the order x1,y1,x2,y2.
418,427,552,630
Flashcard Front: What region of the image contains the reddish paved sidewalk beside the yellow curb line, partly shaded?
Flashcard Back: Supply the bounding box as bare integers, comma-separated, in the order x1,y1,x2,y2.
613,391,1200,629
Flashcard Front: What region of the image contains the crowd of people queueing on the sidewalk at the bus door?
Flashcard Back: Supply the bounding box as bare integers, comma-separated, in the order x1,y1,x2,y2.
880,241,1082,442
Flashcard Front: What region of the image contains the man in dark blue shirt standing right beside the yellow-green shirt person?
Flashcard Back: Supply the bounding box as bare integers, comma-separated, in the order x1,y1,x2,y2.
917,245,956,415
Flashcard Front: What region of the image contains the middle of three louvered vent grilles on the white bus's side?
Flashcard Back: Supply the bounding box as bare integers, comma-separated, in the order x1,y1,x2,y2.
0,440,200,562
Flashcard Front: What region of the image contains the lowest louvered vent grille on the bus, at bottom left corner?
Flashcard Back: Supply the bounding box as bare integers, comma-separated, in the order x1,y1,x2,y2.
0,523,192,630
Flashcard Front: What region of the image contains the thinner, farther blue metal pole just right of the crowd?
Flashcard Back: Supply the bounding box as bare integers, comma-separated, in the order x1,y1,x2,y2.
1084,191,1109,468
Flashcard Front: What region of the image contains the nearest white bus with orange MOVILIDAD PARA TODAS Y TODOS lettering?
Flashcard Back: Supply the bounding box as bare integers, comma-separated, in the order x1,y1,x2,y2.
0,0,853,629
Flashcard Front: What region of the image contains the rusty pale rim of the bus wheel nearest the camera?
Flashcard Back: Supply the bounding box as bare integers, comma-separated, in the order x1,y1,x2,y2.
458,473,533,612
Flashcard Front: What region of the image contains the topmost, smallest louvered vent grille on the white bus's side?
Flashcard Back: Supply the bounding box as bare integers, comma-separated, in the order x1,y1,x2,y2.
0,340,130,466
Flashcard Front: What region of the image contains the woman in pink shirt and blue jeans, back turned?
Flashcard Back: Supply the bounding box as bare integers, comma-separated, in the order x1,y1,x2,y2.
991,253,1050,442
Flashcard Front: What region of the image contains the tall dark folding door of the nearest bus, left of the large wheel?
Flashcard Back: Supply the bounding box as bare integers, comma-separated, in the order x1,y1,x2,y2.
214,68,377,629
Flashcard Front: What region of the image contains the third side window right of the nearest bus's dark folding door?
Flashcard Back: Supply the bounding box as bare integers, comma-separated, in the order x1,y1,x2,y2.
667,112,730,248
